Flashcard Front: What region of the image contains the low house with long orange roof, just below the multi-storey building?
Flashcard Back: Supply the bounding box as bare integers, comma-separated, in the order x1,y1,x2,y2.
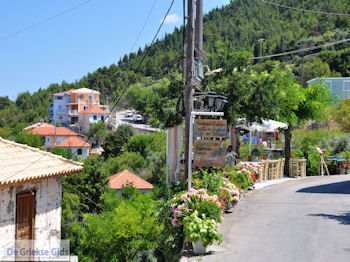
26,126,85,150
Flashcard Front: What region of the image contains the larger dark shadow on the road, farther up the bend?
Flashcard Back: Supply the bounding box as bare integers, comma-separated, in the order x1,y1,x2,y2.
297,181,350,194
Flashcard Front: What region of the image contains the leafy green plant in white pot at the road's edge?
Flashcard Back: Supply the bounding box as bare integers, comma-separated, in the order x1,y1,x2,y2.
183,210,222,255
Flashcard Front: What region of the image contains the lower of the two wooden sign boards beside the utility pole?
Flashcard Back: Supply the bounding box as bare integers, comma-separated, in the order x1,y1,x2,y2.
193,140,226,167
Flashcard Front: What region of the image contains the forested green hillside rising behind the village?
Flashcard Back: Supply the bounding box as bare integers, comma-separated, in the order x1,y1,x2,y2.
0,0,350,137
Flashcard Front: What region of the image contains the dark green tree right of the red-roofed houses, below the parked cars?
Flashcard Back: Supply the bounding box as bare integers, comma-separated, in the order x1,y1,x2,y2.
102,125,134,159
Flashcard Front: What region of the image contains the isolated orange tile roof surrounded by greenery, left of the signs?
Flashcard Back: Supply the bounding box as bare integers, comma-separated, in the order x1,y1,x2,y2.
109,169,153,189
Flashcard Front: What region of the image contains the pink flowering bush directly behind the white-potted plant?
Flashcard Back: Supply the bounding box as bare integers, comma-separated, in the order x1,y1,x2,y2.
172,188,221,227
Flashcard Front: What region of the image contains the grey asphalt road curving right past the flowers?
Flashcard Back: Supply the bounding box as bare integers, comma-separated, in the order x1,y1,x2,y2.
182,175,350,262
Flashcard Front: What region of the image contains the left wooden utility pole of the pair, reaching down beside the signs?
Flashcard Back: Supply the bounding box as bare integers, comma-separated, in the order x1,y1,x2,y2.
184,0,194,179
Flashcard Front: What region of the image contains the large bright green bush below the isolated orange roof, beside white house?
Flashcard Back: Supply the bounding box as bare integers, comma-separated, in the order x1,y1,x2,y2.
77,189,162,261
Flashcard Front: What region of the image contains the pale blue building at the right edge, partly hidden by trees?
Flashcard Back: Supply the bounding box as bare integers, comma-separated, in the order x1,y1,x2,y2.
307,77,350,101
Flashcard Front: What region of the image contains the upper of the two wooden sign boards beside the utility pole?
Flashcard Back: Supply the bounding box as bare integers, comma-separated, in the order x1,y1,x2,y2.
193,119,227,138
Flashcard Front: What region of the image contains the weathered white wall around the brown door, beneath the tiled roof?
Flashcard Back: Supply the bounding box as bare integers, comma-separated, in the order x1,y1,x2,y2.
0,177,62,260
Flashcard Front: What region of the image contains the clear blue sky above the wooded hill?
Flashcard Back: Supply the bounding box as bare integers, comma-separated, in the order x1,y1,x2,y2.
0,0,230,100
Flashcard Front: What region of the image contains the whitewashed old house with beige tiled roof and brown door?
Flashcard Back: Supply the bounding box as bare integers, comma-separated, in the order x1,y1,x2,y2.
0,138,83,261
